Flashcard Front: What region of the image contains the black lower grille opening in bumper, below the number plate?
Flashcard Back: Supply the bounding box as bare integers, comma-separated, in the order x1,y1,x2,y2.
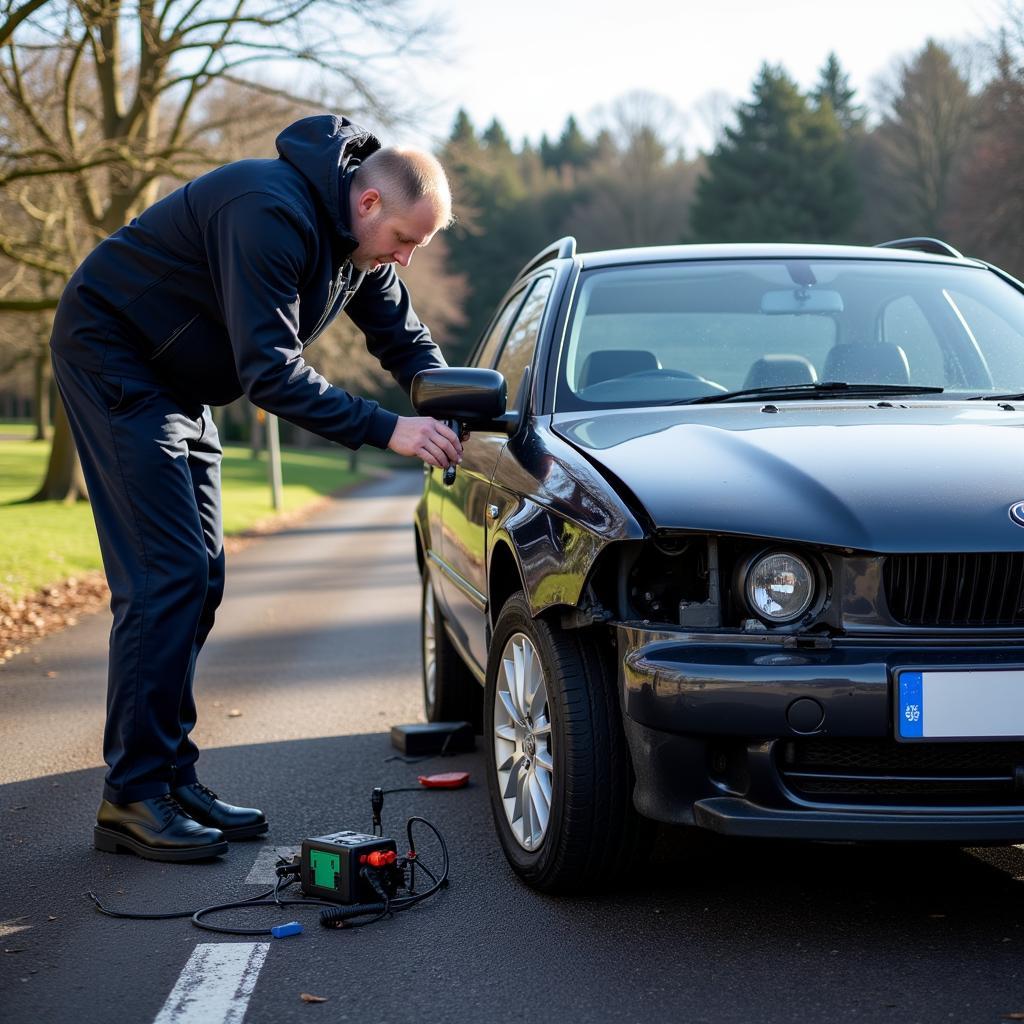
776,739,1024,807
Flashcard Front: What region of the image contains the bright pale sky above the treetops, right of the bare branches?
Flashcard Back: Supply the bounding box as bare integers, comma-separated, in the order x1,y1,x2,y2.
390,0,1000,155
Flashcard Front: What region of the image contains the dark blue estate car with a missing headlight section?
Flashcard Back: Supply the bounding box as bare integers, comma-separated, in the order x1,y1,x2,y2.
416,239,1024,890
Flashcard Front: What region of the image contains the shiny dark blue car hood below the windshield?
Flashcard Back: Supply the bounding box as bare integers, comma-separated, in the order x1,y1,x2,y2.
552,401,1024,553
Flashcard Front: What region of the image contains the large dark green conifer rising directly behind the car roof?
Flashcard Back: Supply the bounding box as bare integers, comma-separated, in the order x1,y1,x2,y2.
690,65,860,242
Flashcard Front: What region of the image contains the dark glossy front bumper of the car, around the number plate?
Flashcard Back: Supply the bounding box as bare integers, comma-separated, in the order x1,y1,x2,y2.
616,624,1024,844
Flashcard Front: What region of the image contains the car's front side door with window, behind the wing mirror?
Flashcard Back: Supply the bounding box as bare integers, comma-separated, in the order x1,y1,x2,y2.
441,273,554,669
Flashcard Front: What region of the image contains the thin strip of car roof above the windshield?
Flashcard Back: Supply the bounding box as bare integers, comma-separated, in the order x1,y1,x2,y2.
577,242,984,269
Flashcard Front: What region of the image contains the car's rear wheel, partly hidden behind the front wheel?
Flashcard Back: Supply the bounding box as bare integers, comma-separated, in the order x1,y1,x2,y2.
420,573,483,733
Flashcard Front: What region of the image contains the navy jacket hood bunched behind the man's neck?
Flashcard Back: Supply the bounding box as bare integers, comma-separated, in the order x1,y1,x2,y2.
276,114,381,236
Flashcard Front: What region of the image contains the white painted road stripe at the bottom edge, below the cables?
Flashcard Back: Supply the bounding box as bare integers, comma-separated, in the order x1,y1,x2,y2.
154,942,270,1024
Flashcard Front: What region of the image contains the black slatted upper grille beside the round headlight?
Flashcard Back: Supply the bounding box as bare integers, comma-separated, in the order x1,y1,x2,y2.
882,551,1024,628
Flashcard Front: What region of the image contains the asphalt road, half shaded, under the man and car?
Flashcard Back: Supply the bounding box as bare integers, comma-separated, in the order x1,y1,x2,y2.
0,473,1024,1024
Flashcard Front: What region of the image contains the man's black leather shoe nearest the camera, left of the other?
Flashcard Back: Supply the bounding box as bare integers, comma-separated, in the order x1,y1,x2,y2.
92,795,227,860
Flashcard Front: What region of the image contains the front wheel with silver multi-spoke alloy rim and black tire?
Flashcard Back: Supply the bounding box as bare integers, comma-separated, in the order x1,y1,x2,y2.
483,592,652,893
